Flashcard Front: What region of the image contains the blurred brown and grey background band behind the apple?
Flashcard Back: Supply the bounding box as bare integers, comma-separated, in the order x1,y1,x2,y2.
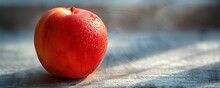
0,0,220,32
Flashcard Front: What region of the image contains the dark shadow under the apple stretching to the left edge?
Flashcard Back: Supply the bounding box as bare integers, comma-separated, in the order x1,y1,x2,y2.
0,67,85,87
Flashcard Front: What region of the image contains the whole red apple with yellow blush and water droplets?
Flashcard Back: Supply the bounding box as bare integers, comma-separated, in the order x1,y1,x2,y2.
34,7,108,78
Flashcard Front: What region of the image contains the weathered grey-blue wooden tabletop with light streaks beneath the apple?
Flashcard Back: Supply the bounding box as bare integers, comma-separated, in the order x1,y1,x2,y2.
0,31,220,88
